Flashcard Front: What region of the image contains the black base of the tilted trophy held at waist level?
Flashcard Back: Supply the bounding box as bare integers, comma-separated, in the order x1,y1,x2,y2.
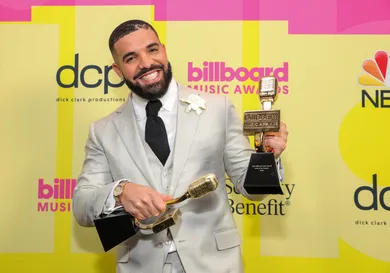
94,209,139,252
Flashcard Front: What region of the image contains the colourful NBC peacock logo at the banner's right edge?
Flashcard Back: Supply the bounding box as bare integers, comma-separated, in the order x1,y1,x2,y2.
358,50,390,87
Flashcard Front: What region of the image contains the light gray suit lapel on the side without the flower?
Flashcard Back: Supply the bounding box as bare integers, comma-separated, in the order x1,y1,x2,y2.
114,98,160,187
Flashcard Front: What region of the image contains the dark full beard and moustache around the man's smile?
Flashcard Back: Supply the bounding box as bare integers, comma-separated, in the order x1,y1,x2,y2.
124,62,172,100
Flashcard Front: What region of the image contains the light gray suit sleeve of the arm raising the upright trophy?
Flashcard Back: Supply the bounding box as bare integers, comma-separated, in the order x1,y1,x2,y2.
224,97,283,201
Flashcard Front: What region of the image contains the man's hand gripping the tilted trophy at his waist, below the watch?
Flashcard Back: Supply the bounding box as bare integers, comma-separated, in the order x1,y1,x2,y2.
119,183,172,220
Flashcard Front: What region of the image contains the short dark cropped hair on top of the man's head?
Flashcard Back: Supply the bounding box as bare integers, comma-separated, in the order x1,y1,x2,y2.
108,19,159,53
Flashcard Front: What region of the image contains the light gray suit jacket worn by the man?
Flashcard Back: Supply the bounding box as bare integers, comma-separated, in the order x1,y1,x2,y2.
73,86,280,273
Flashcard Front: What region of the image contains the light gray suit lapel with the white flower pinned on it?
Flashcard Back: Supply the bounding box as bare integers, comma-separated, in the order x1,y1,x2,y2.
171,85,199,191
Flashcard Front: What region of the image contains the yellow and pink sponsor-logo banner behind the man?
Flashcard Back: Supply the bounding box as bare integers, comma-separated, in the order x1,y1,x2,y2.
0,0,390,273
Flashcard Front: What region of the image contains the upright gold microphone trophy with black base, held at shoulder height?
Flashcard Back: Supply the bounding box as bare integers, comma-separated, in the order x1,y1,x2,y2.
243,76,283,194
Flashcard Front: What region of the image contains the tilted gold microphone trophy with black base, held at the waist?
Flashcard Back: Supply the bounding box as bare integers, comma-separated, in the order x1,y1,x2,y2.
94,174,219,252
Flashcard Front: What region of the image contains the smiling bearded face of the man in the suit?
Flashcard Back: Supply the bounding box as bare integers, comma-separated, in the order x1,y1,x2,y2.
109,29,172,100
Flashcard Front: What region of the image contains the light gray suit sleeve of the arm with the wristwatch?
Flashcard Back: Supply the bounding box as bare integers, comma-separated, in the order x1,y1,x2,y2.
72,123,119,226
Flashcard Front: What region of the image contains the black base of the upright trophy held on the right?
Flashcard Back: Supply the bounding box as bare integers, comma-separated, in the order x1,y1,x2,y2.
244,153,283,194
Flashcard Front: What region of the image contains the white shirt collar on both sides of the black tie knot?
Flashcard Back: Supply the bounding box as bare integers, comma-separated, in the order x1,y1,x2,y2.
131,77,178,119
